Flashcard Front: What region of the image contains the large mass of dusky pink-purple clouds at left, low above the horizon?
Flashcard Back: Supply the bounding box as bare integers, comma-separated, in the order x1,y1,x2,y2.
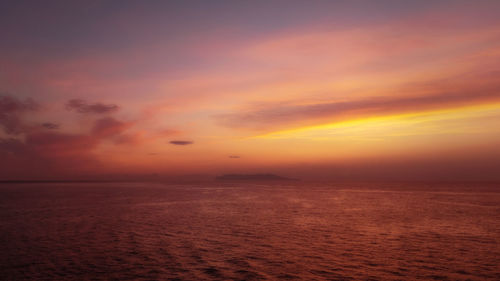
0,96,138,178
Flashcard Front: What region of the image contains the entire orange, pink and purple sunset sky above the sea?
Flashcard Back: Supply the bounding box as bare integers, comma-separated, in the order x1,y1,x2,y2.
0,0,500,181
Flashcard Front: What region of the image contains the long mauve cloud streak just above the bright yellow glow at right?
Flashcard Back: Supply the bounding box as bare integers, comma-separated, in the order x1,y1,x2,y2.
215,87,500,131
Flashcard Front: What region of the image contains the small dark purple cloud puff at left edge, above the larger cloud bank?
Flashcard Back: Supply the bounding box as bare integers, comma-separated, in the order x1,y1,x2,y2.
0,95,39,135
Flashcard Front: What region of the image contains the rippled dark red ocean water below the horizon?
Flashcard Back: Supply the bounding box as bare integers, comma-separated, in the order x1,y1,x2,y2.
0,182,500,280
